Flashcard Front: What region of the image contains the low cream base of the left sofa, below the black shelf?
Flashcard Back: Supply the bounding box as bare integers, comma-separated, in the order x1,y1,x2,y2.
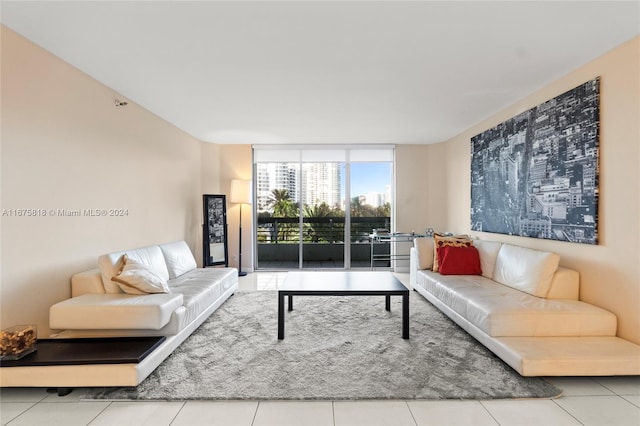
0,283,238,389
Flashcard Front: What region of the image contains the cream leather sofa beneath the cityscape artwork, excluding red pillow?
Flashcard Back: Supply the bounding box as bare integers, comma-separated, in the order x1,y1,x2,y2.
410,238,640,376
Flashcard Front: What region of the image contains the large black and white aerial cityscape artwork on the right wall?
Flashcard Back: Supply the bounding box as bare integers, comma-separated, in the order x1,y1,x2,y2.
471,78,600,244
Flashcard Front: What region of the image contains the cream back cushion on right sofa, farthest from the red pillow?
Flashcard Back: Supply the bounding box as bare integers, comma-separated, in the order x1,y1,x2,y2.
493,244,560,297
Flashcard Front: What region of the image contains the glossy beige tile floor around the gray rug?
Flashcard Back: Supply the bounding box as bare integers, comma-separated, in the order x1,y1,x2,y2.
0,272,640,426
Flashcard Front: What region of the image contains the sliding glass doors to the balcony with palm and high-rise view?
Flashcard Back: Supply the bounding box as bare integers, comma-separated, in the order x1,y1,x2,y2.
254,146,393,270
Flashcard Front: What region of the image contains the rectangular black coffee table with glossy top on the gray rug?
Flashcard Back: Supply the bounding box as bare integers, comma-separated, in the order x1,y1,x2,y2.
278,271,409,340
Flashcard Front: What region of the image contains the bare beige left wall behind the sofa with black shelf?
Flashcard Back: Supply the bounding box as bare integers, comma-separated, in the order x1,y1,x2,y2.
0,27,202,336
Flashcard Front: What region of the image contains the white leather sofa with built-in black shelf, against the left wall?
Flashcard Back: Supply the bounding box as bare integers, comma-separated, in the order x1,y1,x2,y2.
2,241,238,388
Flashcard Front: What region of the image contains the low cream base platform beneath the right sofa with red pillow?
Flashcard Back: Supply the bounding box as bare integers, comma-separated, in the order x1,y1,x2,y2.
414,285,640,376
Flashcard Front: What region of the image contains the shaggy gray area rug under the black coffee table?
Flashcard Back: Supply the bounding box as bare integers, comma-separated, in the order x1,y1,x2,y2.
74,291,562,400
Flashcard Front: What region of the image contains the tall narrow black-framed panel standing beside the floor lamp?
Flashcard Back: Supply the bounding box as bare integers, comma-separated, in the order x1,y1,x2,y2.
202,194,229,267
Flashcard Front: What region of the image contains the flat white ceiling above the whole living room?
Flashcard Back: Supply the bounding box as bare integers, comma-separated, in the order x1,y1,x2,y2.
0,0,640,144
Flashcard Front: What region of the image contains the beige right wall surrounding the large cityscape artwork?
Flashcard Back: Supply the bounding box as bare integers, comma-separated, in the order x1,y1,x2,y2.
442,37,640,343
